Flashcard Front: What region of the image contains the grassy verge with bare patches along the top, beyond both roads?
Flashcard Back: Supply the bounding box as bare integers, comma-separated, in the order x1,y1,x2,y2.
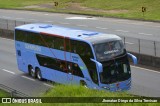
0,0,160,21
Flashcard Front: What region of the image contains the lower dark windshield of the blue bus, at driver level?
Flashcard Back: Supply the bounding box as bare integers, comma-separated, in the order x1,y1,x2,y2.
100,55,131,84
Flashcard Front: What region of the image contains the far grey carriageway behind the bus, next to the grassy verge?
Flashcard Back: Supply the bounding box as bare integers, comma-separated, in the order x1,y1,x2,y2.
0,9,160,57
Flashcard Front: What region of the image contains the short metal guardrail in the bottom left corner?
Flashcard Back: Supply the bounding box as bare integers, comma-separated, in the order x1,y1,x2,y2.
0,84,29,97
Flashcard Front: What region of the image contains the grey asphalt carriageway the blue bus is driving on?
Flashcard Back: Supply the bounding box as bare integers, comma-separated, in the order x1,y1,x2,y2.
0,38,160,97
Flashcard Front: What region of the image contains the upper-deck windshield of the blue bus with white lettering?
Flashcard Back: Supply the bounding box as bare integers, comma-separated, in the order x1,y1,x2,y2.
94,40,124,61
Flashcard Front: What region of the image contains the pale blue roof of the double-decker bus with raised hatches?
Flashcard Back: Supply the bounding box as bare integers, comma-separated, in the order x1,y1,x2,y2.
15,23,121,43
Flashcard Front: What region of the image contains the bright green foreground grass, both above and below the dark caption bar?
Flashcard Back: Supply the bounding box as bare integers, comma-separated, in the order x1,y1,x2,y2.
0,84,159,106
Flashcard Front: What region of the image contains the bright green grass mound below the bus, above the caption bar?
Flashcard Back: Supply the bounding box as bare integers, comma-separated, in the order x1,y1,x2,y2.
44,85,133,97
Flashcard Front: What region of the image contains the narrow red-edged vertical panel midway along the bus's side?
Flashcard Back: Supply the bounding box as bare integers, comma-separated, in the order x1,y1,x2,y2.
64,38,73,83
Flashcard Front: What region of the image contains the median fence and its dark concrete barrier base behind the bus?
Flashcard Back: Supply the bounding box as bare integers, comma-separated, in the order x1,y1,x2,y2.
0,19,160,68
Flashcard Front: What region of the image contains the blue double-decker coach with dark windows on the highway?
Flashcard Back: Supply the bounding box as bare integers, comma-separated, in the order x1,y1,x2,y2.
14,23,137,91
